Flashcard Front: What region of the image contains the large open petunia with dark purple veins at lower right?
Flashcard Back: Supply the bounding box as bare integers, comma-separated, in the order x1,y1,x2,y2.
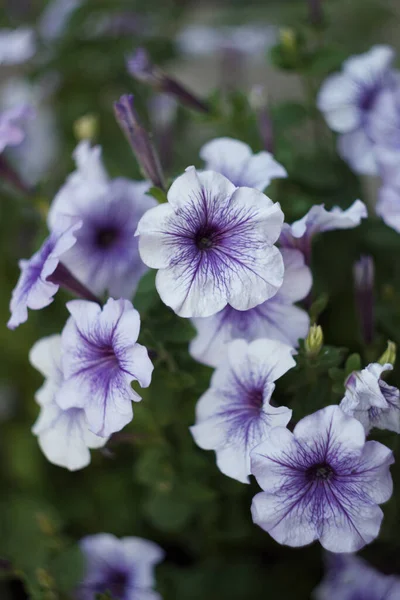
251,406,394,552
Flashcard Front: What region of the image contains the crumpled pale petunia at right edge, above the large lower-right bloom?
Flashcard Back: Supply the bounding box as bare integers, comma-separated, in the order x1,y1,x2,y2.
340,363,400,434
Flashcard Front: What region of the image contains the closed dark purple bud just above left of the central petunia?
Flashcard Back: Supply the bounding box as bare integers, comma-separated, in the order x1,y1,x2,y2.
114,94,165,190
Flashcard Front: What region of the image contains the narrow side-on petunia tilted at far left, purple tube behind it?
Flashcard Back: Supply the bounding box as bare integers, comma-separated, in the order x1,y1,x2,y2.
7,216,82,329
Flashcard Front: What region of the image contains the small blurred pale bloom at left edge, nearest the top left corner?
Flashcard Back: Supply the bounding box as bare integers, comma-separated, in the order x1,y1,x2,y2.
0,27,36,65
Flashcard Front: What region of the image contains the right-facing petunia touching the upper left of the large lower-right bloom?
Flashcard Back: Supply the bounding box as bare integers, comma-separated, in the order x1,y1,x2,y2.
190,339,296,483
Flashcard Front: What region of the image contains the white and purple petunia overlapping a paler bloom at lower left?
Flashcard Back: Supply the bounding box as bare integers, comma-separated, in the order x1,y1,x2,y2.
57,298,153,437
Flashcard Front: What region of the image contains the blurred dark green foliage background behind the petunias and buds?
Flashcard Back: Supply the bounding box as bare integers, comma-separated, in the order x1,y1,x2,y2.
0,0,400,600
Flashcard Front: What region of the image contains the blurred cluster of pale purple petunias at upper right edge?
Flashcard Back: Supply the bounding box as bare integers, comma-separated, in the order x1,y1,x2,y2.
318,46,400,236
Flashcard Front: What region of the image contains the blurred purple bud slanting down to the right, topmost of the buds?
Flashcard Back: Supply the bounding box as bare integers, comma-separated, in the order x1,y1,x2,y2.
126,48,209,113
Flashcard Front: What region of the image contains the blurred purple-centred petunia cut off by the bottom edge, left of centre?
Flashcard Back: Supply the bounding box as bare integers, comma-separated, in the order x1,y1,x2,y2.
76,533,164,600
